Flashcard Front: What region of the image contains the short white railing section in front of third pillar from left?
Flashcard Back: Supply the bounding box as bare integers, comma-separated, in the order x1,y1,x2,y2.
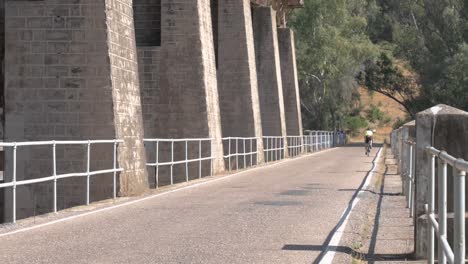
223,137,258,171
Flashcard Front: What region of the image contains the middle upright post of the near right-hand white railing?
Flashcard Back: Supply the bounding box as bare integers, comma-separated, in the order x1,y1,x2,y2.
437,159,447,264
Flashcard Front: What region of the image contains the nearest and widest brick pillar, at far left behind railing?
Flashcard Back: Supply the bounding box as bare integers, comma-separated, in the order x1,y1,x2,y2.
5,0,147,223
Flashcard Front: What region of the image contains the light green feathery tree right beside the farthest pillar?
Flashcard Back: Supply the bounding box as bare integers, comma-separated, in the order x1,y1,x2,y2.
288,0,378,129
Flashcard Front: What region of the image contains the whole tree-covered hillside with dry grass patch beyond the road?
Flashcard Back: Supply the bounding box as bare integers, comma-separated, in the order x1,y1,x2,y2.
289,0,468,135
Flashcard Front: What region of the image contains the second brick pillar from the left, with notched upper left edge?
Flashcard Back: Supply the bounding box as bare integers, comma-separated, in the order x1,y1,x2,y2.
140,0,224,184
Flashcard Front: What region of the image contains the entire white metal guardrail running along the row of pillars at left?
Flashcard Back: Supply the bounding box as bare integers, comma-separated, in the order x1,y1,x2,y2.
0,131,346,223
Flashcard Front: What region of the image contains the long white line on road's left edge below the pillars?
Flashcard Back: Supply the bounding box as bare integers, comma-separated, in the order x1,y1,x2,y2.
0,148,338,238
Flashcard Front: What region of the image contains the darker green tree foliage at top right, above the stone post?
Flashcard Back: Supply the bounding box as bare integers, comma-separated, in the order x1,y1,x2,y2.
369,0,468,111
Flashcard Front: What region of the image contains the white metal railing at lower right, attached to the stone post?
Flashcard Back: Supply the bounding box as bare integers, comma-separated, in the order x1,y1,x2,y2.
425,146,468,264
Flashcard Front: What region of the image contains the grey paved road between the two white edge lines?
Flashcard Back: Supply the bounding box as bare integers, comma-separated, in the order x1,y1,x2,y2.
0,147,375,263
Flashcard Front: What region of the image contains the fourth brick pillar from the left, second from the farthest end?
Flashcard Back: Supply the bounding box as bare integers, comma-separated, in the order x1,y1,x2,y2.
252,7,287,155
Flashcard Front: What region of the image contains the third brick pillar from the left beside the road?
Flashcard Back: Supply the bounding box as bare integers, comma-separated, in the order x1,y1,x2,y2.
217,0,263,167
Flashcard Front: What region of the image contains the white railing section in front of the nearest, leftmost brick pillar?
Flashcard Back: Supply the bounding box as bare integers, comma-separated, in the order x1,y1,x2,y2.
0,139,123,223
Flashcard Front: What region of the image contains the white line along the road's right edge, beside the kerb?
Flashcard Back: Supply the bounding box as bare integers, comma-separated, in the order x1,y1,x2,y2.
320,148,383,264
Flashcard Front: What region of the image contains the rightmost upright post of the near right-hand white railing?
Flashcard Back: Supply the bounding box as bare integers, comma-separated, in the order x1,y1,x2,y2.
453,166,466,264
